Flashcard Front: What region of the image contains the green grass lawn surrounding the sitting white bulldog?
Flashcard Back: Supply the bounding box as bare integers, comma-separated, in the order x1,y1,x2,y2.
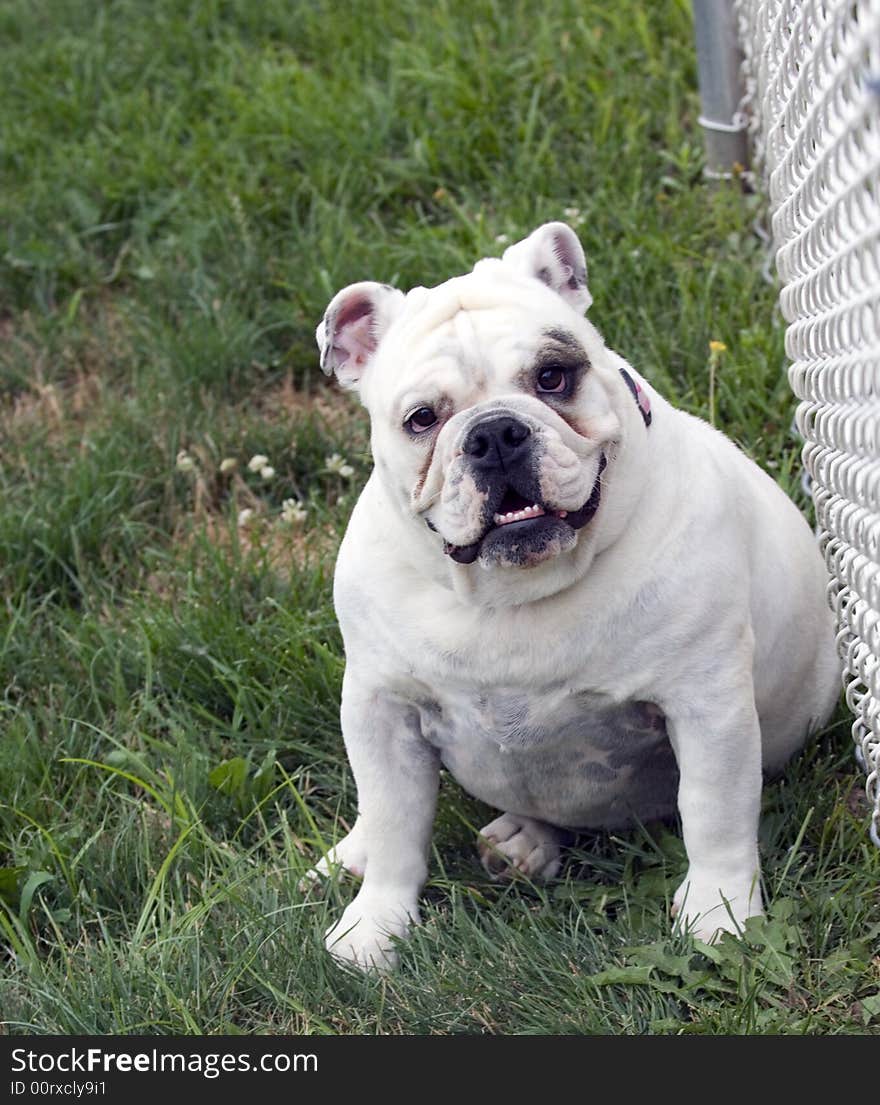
0,0,880,1033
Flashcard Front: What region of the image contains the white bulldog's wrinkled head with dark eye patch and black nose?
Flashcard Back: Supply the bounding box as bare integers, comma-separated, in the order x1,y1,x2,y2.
316,223,650,605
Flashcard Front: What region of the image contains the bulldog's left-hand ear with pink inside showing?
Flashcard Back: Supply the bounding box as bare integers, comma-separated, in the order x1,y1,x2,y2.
315,281,406,391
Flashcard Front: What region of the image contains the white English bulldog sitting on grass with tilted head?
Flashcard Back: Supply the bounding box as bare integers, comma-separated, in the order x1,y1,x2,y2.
314,222,839,969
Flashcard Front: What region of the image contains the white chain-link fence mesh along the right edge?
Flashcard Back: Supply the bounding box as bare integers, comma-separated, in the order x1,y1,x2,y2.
735,0,880,846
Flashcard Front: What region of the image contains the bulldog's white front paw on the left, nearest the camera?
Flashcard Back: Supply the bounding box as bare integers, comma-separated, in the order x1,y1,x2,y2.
325,891,419,971
